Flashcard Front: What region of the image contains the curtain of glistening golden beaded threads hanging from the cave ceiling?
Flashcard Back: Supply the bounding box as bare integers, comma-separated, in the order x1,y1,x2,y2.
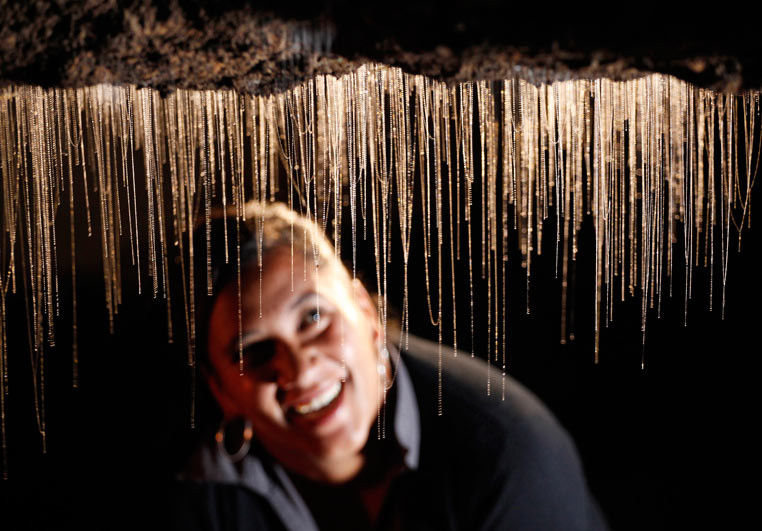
0,64,762,480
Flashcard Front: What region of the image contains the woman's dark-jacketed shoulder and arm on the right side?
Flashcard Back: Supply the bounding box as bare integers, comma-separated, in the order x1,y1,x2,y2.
402,336,606,531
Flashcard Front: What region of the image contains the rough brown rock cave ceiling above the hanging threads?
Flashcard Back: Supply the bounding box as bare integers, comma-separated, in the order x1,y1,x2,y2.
0,0,762,93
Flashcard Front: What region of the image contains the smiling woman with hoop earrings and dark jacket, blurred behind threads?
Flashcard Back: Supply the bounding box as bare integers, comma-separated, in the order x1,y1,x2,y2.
173,203,606,530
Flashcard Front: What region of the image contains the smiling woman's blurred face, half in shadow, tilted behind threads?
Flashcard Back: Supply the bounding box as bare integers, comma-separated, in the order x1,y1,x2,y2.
203,247,382,483
